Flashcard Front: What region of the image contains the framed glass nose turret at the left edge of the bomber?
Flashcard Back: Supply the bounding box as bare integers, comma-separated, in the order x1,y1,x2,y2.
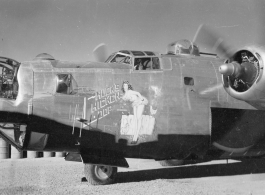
0,57,20,99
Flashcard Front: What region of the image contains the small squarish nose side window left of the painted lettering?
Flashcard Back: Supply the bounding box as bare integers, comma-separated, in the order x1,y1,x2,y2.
56,74,77,95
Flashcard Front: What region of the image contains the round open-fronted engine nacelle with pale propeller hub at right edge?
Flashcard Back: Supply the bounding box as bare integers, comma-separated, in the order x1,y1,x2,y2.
219,47,265,102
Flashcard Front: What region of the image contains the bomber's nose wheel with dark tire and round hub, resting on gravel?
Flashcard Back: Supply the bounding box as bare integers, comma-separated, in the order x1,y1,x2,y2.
84,164,118,185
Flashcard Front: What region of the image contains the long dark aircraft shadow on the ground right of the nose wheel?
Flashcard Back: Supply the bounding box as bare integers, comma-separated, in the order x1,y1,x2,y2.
116,160,265,183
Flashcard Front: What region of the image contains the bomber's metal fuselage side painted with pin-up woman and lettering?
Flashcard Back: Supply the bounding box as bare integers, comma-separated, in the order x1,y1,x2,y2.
0,55,264,165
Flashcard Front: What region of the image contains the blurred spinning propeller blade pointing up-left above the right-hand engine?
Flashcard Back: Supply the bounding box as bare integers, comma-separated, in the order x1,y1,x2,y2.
193,25,235,58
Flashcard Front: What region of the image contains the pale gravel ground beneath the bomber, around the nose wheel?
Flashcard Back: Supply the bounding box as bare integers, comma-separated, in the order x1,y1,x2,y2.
0,158,265,195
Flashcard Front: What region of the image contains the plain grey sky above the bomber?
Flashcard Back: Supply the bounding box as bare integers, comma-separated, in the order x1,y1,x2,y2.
0,0,260,62
